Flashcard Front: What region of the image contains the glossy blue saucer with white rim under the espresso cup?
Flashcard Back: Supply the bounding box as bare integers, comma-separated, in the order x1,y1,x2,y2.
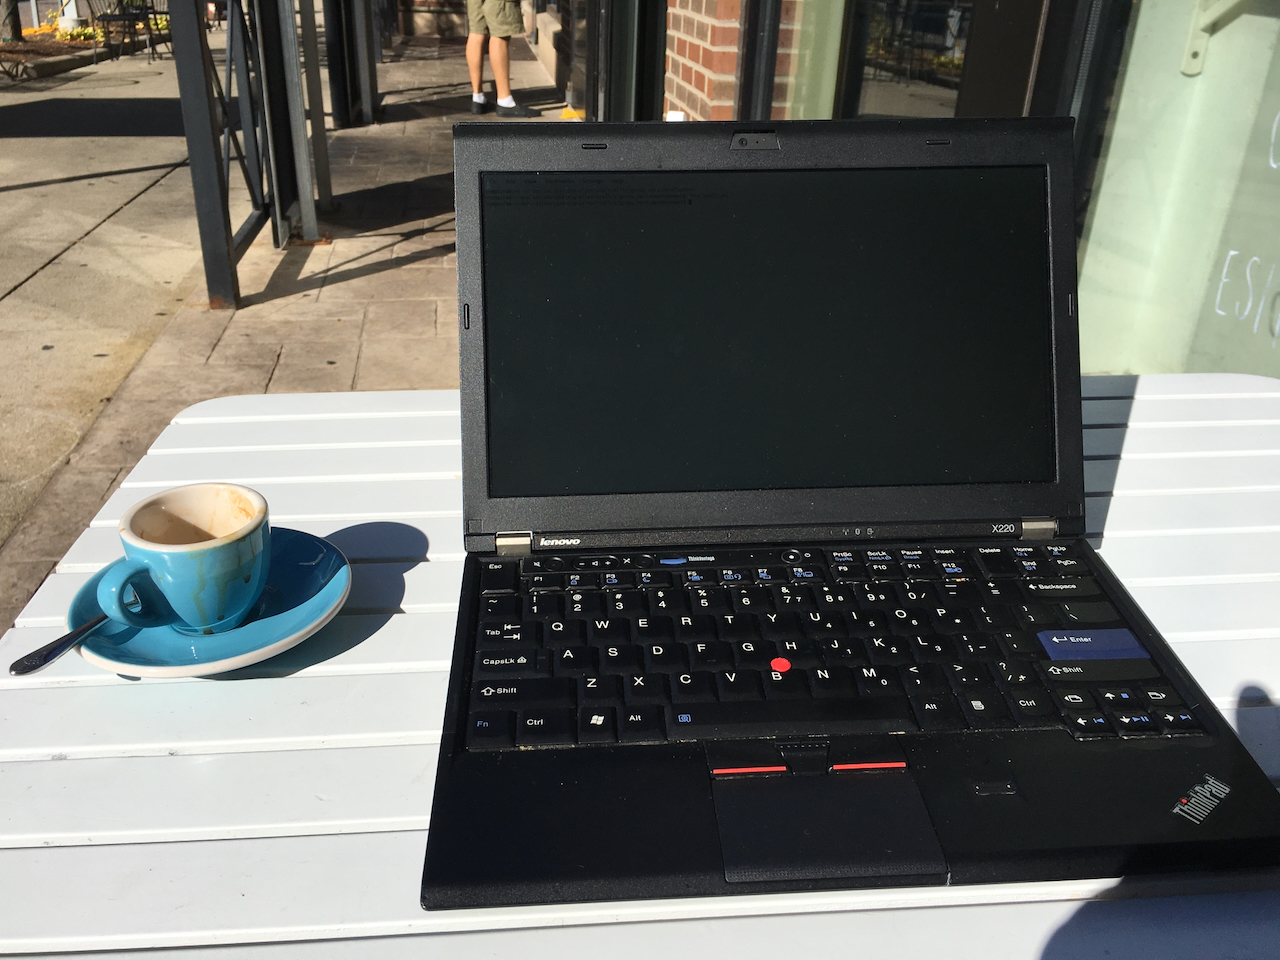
67,527,351,677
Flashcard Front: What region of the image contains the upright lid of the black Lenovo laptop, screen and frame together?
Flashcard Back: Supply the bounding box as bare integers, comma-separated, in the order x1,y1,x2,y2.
454,119,1084,552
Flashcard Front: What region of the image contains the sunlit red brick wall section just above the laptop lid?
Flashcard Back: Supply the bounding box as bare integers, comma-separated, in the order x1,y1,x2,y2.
662,0,750,120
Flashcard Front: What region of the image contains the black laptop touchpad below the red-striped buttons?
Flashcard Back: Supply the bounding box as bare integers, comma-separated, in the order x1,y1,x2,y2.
712,771,947,883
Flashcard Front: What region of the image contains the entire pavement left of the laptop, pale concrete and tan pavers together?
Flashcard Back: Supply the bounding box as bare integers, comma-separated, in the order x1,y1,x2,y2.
0,35,563,632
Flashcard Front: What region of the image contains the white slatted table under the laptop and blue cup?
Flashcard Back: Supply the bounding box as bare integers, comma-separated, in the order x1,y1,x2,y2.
0,374,1280,960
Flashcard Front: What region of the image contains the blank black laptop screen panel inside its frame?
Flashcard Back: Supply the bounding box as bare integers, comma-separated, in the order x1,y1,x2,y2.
481,166,1055,497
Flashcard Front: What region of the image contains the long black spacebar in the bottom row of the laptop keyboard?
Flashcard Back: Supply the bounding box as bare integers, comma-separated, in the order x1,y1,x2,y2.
668,696,919,740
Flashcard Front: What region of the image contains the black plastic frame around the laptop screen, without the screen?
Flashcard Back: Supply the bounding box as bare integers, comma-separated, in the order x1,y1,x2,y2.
454,119,1084,550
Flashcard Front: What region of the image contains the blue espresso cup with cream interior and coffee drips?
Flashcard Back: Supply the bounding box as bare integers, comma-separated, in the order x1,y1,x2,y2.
97,484,271,636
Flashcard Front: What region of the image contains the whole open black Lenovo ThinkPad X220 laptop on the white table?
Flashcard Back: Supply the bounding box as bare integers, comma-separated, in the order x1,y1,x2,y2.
421,119,1280,909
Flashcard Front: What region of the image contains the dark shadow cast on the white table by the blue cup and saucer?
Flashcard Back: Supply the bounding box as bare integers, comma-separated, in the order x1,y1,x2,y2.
210,521,430,680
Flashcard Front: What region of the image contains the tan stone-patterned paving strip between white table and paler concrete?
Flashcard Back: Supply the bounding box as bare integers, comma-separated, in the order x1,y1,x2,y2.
0,38,562,632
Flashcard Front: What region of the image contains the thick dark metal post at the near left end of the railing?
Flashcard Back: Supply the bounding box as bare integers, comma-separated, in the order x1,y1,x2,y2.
169,0,239,310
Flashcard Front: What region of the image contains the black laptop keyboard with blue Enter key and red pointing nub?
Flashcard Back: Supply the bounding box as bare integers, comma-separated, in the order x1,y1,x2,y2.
467,543,1202,750
